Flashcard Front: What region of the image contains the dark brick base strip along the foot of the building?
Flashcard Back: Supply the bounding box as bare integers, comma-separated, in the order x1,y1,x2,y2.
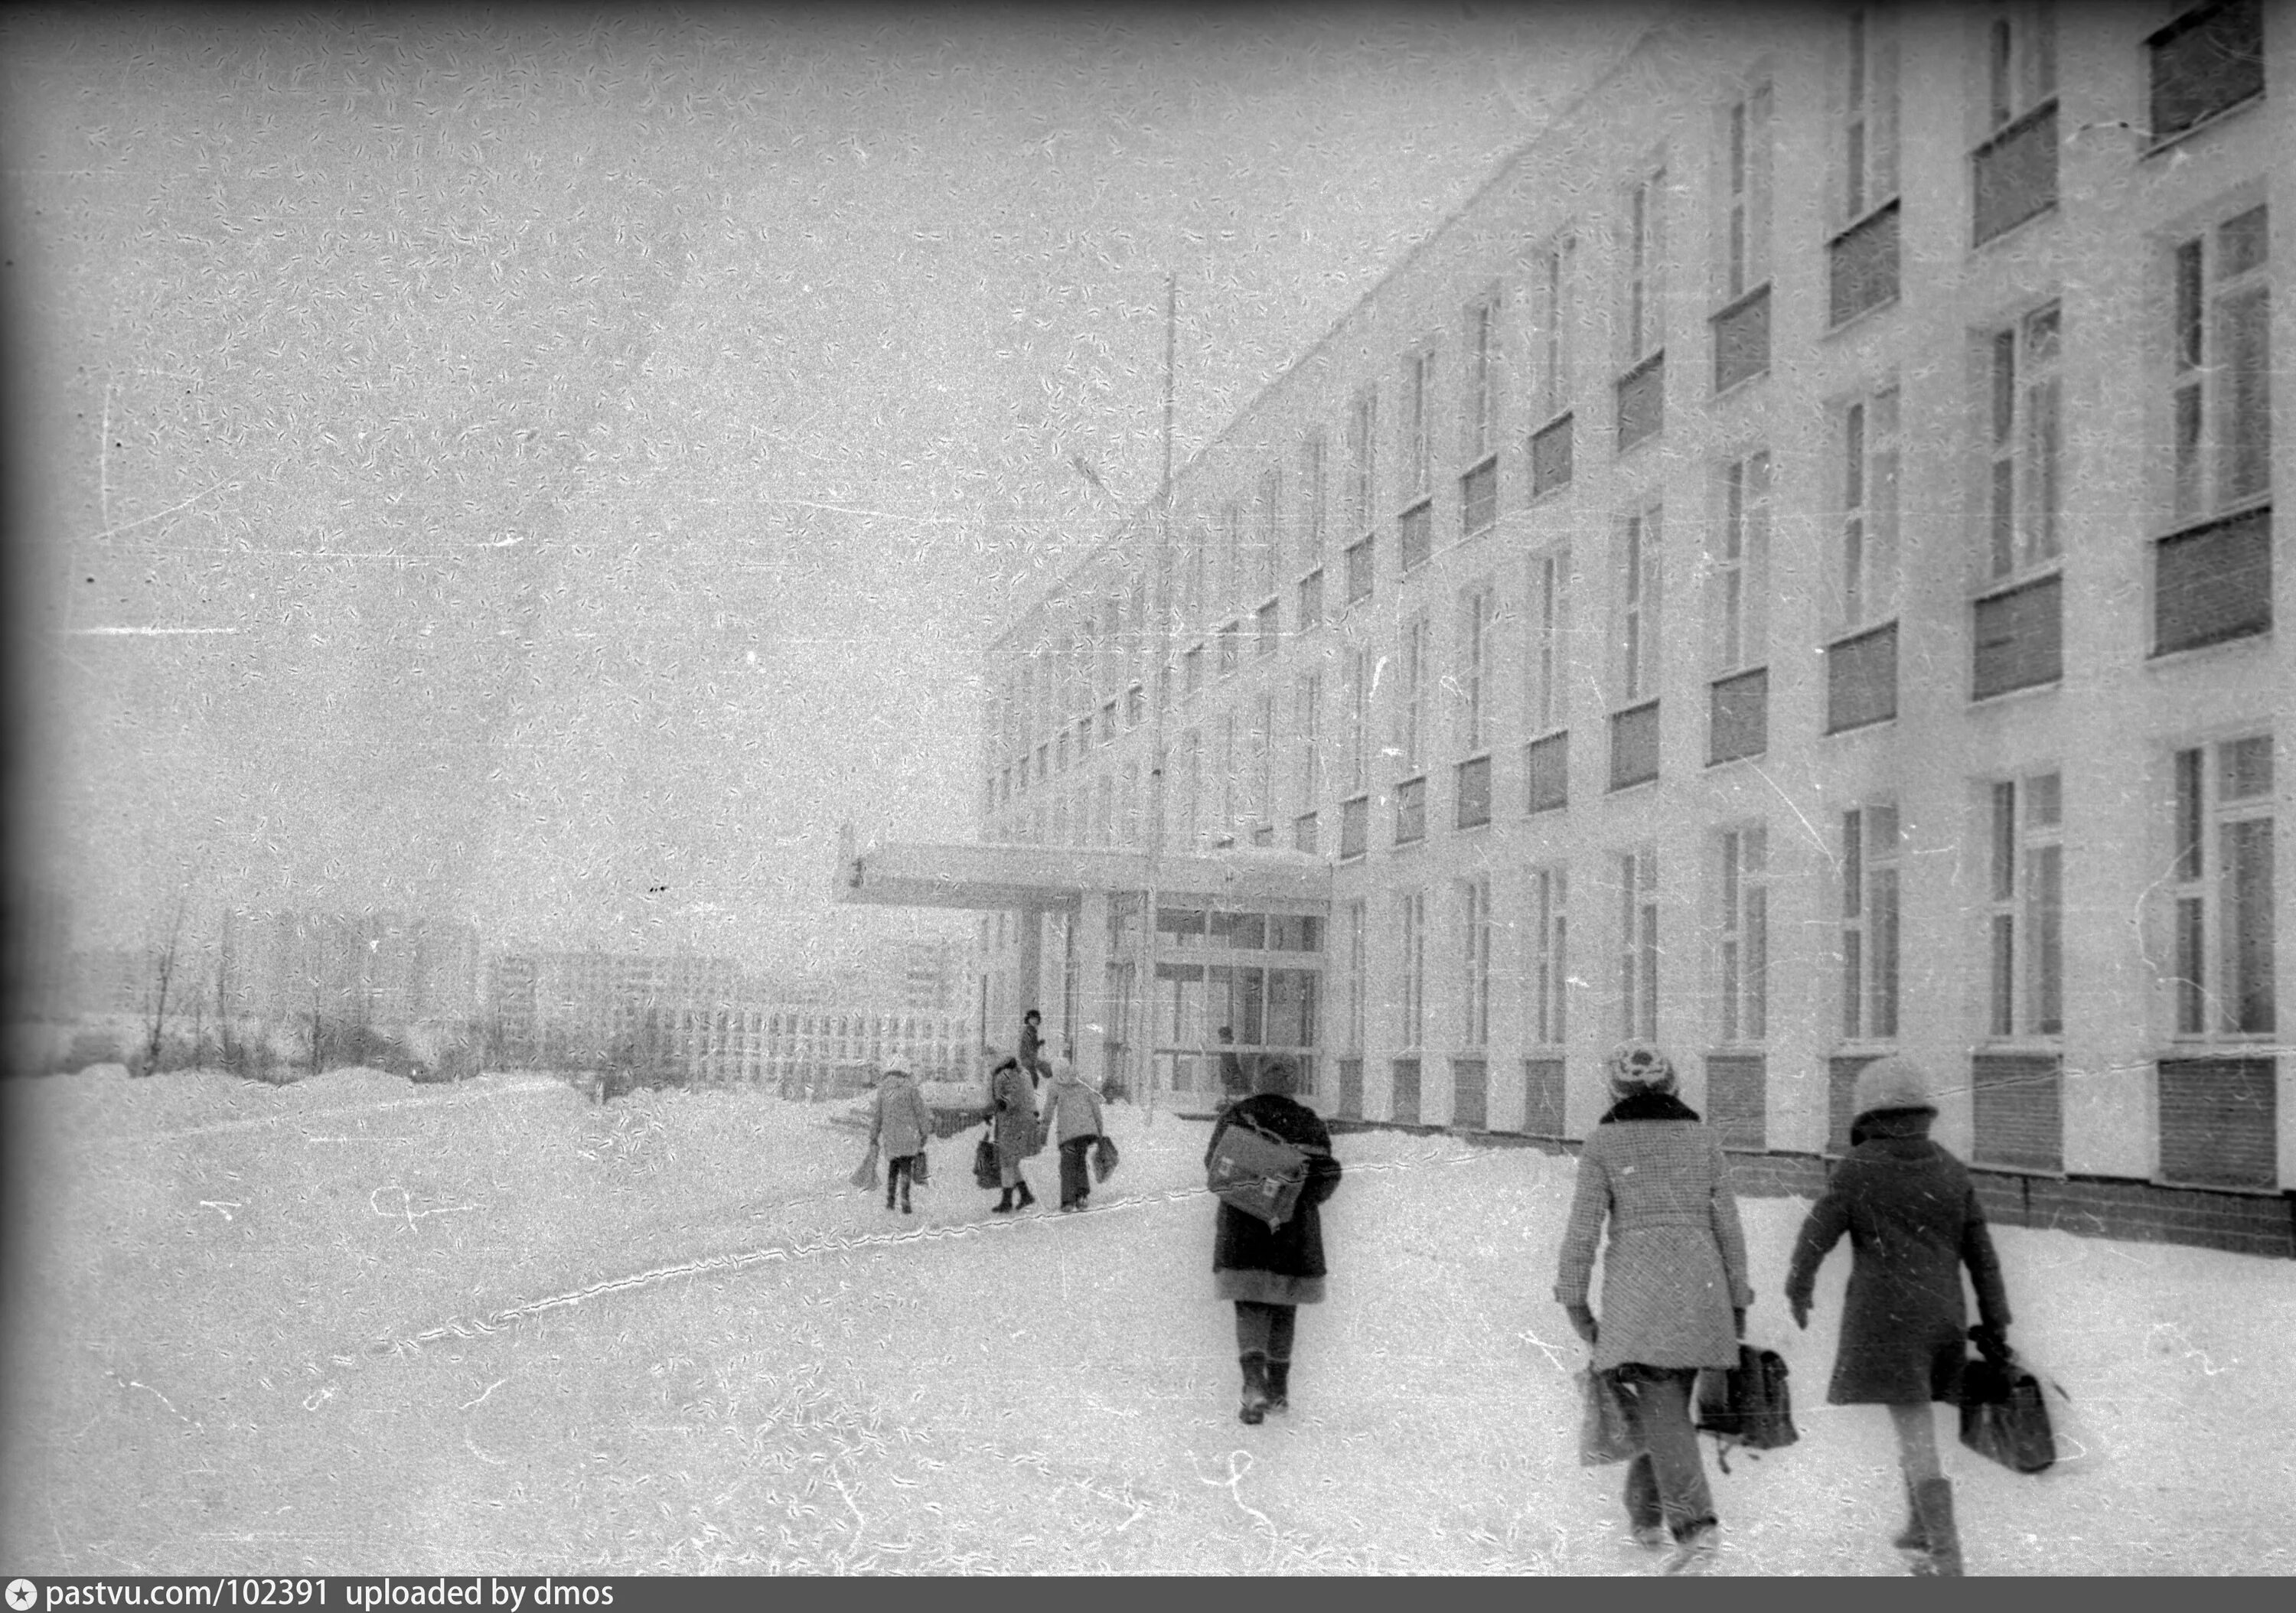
1325,1119,2296,1259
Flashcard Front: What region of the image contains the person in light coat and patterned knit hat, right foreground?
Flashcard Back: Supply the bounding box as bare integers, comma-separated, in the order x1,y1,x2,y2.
1554,1041,1754,1574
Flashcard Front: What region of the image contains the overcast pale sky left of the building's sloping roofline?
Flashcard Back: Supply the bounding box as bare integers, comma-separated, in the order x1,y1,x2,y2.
0,5,1646,966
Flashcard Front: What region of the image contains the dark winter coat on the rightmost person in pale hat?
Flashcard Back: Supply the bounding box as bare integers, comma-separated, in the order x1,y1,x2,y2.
1786,1117,2009,1406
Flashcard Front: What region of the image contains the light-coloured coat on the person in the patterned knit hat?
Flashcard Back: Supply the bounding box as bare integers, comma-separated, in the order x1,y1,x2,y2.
1554,1119,1754,1370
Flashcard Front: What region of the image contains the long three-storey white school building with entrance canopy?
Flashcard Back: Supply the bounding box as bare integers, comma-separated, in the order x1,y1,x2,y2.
843,0,2296,1250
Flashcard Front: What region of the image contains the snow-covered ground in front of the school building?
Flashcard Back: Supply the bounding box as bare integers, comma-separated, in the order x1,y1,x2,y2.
0,1071,2296,1574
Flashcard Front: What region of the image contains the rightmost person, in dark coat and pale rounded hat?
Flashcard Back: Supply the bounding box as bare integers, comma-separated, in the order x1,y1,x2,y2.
1786,1057,2009,1576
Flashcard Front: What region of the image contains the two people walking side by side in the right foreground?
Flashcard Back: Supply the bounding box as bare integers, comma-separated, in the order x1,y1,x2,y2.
1554,1041,2009,1574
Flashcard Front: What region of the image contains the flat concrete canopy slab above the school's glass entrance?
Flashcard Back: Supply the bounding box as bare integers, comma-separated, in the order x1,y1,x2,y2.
831,837,1332,913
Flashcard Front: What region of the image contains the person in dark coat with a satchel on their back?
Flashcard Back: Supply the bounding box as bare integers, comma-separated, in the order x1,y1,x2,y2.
1203,1055,1341,1422
